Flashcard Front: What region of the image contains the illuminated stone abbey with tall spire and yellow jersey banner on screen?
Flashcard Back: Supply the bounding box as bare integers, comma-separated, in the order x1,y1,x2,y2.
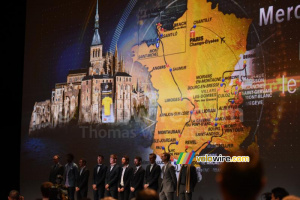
29,1,151,133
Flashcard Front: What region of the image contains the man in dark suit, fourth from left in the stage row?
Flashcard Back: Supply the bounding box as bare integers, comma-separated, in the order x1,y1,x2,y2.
93,155,107,200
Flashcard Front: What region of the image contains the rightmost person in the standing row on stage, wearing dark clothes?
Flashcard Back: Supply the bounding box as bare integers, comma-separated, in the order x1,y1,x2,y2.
177,164,197,200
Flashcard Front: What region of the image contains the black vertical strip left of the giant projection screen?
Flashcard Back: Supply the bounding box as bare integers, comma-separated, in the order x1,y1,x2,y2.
0,0,26,199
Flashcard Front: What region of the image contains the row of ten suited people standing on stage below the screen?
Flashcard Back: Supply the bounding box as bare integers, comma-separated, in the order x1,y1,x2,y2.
49,153,197,200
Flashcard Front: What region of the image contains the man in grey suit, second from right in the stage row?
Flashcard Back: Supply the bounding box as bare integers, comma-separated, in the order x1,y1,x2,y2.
159,153,177,200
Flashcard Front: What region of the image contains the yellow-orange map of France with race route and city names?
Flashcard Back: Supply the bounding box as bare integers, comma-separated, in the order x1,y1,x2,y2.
132,0,252,159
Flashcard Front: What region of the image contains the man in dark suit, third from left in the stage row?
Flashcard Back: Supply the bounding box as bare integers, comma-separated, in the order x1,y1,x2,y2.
75,158,90,200
